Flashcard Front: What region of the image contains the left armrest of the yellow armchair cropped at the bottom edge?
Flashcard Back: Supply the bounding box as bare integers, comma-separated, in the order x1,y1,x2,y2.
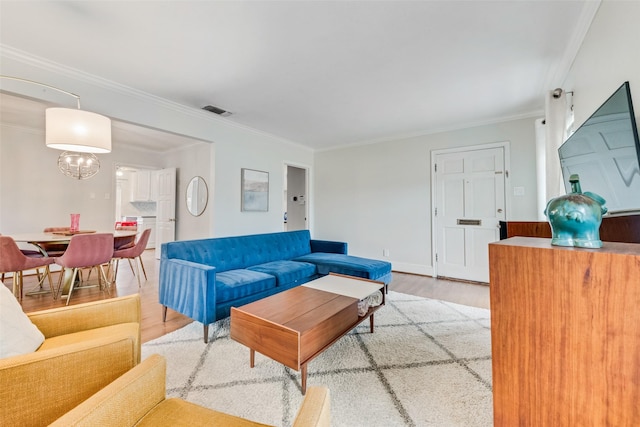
51,354,166,427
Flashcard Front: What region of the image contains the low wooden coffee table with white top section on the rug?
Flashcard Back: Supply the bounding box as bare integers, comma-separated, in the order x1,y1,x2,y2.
231,274,384,394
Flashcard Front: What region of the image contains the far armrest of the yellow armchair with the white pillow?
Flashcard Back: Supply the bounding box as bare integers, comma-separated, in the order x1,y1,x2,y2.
27,294,142,342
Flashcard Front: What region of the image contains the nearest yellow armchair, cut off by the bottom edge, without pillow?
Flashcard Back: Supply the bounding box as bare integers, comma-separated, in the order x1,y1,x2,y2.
51,354,331,427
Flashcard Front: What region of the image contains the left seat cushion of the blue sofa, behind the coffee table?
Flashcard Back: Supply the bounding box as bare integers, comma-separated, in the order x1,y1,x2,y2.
216,269,276,304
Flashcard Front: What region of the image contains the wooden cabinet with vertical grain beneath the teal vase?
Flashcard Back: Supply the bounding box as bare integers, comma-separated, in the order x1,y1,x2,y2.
489,237,640,427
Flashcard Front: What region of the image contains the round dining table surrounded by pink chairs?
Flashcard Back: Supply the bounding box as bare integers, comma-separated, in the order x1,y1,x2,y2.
9,230,138,295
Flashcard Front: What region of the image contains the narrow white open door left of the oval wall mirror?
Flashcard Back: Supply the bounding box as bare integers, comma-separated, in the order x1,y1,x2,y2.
155,168,176,259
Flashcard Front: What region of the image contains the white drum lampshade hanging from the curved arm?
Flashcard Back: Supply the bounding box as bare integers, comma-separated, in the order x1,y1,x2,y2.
45,108,111,153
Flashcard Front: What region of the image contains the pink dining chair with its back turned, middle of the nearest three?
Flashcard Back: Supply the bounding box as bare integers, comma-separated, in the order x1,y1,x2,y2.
54,233,113,305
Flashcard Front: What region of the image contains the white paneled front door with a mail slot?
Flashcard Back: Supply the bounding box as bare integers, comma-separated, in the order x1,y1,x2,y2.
434,147,506,283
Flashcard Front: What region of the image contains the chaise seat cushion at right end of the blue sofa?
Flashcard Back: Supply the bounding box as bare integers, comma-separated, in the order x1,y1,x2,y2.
293,252,391,280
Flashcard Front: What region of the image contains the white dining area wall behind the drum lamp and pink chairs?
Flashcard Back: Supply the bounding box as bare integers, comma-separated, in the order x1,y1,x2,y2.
0,125,163,234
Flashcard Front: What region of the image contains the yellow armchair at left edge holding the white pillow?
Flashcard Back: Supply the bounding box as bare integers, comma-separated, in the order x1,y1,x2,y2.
0,294,141,426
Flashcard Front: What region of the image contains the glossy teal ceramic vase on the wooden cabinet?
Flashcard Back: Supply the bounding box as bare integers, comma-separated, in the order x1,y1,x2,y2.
544,175,607,248
